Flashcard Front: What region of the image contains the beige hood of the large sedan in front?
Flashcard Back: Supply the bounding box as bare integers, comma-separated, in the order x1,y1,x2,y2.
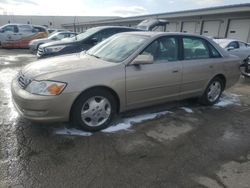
22,53,115,79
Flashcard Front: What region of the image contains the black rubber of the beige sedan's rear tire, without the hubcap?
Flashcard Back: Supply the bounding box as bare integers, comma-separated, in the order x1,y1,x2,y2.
200,77,225,106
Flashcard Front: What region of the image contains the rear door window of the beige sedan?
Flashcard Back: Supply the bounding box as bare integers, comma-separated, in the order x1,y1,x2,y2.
183,37,209,60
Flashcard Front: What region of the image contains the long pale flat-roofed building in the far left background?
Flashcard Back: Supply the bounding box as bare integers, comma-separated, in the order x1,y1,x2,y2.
0,15,116,29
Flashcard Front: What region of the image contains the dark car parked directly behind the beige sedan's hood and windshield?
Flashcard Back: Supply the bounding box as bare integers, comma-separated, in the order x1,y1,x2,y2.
37,26,142,58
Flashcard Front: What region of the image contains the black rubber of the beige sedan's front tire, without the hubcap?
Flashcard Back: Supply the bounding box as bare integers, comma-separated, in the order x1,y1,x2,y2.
71,89,117,132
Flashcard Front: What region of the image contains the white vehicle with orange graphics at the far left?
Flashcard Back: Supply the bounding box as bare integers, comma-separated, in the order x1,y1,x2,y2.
0,24,48,48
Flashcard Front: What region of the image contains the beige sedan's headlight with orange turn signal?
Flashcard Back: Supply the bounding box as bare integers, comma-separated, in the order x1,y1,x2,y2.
25,80,67,96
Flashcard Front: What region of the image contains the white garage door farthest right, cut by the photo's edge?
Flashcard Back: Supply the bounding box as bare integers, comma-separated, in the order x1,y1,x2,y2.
227,19,250,42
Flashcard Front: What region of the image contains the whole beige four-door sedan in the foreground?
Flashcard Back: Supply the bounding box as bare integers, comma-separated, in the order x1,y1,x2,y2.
12,32,240,131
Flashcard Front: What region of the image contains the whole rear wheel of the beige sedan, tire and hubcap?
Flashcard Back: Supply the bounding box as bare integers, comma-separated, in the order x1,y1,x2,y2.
200,77,224,106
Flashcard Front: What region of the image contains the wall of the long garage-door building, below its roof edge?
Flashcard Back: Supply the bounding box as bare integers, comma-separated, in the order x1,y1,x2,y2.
64,11,250,42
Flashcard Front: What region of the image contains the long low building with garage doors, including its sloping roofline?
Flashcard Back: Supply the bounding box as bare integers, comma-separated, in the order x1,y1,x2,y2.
62,3,250,42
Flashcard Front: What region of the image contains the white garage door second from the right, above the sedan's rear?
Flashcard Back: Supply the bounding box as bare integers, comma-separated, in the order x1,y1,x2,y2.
202,21,221,37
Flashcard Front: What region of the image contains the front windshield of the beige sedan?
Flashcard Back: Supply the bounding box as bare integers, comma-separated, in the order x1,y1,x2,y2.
87,34,148,63
